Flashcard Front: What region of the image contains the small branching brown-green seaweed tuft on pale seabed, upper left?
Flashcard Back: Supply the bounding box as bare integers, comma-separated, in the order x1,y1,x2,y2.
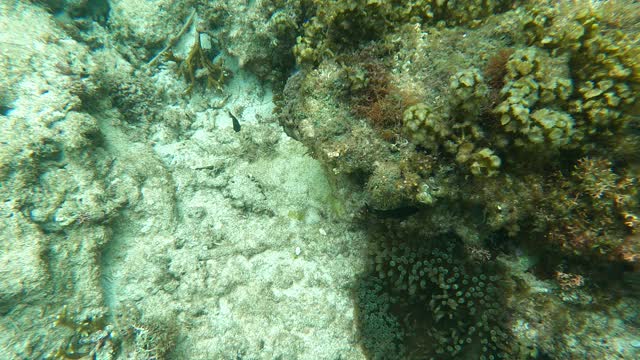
180,29,229,94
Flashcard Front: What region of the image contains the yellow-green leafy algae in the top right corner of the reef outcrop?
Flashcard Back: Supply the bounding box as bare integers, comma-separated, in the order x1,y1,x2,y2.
525,4,640,153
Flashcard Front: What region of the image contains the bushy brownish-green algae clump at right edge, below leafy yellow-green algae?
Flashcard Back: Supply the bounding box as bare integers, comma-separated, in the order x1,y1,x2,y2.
546,158,640,262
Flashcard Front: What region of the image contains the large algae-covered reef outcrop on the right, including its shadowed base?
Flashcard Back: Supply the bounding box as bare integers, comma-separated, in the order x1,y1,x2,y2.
280,1,640,358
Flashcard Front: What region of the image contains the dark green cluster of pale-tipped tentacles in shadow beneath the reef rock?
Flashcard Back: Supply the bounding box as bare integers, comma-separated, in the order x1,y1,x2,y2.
365,231,511,359
